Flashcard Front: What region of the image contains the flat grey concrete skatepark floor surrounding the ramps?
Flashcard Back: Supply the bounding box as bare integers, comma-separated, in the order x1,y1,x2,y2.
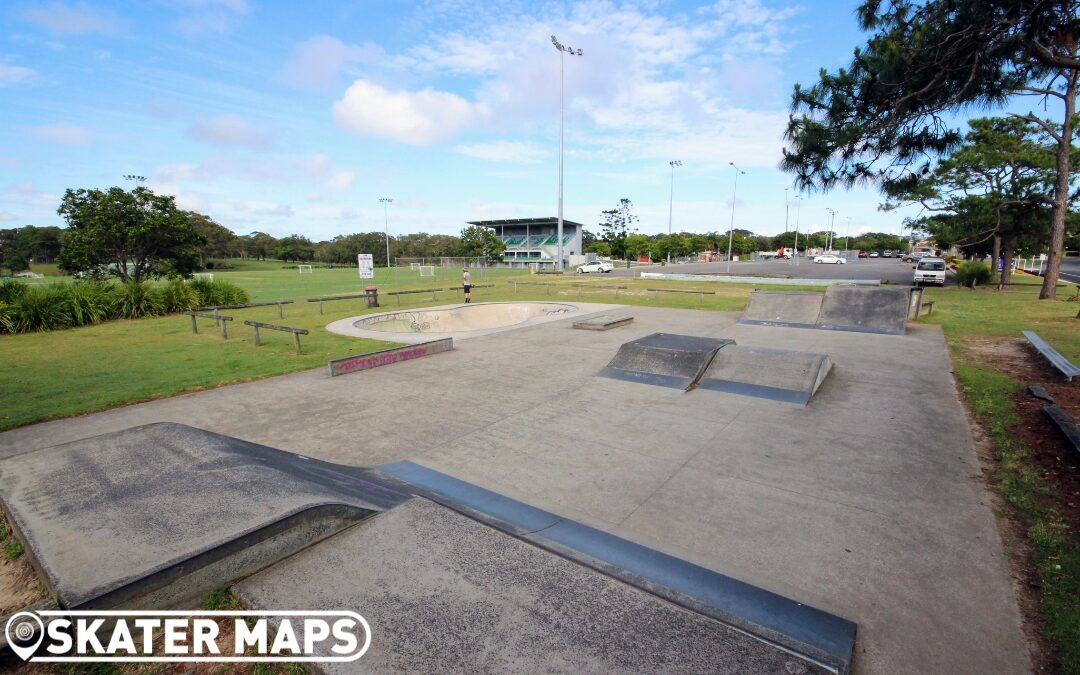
0,307,1030,673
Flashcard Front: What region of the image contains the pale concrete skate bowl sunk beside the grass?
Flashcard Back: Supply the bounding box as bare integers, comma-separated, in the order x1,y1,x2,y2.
326,302,617,342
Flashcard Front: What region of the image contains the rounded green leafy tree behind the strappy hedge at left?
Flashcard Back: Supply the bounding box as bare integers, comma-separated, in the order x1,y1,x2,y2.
56,187,206,282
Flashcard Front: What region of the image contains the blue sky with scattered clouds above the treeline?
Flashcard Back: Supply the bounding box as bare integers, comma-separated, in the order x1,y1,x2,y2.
0,0,954,241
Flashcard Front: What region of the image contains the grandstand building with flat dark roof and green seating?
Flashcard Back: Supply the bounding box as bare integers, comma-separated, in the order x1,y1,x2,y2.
469,218,584,268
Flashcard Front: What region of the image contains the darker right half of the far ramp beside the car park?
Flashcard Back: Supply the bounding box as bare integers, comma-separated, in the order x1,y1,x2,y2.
818,286,910,335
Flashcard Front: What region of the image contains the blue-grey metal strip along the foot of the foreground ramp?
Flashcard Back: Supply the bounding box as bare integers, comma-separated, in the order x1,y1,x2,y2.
375,461,856,673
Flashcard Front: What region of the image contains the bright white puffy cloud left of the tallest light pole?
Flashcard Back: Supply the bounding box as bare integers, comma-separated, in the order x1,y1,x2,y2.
333,80,486,146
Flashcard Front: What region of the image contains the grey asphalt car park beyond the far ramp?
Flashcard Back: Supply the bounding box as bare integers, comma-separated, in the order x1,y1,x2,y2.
611,252,928,286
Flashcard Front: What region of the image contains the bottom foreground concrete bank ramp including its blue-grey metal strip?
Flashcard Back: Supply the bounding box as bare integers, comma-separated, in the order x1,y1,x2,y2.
234,462,855,674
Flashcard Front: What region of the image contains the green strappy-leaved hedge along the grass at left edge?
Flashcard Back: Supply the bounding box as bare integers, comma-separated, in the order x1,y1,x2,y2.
0,279,248,333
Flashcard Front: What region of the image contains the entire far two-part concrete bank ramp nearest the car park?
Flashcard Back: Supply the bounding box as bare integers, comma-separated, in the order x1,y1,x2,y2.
739,285,910,335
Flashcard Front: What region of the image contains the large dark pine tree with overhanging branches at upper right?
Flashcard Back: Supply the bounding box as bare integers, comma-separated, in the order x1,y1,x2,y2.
782,0,1080,298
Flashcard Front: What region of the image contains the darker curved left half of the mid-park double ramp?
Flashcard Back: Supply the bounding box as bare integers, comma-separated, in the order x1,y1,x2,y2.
598,333,733,390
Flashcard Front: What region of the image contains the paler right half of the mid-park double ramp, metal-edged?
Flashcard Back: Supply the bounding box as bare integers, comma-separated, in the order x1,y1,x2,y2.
698,345,833,405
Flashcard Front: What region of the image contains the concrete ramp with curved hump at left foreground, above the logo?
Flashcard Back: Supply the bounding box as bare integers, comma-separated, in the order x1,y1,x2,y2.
0,423,406,609
